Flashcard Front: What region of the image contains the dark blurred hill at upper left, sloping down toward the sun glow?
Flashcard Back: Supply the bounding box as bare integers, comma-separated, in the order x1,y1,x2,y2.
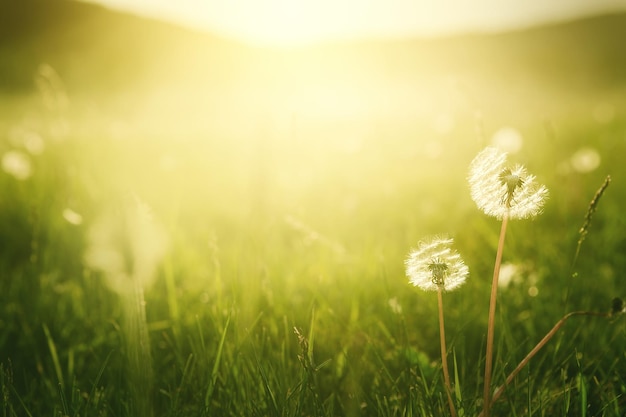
0,0,245,91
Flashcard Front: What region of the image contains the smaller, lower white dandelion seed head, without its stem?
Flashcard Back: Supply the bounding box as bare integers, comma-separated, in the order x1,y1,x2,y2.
404,236,469,291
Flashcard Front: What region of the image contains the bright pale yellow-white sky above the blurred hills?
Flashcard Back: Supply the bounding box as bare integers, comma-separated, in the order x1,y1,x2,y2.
88,0,626,45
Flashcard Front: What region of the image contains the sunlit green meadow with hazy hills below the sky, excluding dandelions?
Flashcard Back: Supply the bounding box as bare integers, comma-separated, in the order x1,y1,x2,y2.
0,0,626,417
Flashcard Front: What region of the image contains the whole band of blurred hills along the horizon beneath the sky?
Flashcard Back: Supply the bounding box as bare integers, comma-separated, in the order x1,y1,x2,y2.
0,0,626,90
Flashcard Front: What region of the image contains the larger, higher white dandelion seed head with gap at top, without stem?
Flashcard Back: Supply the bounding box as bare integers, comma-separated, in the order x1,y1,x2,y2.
468,147,548,219
